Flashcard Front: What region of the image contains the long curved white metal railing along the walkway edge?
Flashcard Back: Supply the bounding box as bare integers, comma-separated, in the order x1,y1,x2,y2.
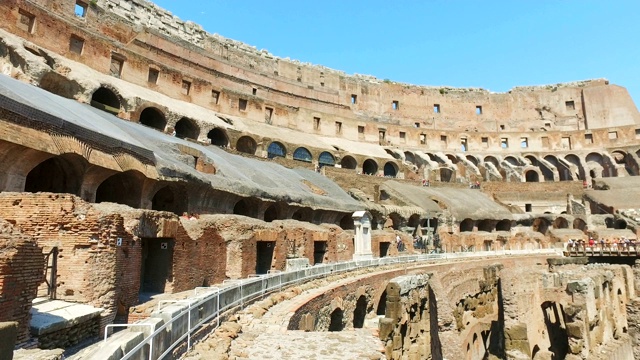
103,249,562,360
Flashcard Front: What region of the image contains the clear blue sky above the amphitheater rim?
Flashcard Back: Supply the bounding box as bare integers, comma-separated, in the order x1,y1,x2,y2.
154,0,640,106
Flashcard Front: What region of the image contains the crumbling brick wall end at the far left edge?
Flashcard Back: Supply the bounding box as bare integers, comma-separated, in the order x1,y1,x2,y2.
0,216,45,344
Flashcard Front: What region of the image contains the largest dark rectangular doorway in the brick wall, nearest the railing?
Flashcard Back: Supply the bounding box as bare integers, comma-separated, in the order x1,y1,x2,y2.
140,238,175,293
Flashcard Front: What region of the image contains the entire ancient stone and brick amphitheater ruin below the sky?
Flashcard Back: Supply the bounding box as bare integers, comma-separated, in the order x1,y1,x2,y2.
0,0,640,360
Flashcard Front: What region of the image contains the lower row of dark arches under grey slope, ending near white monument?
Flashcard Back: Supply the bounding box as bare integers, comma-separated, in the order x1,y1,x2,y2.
14,149,353,229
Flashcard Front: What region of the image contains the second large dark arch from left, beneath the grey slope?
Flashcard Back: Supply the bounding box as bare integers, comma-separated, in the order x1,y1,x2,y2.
96,170,144,208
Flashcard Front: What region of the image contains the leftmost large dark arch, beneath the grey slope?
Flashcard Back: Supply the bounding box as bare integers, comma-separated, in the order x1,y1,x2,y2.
24,154,87,195
